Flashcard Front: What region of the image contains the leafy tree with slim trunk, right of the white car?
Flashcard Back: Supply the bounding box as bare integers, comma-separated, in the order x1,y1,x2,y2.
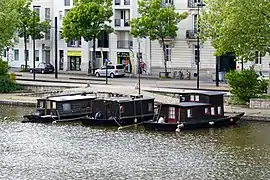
130,0,188,77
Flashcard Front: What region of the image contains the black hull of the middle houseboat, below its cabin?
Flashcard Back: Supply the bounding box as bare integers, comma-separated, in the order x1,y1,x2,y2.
81,116,153,127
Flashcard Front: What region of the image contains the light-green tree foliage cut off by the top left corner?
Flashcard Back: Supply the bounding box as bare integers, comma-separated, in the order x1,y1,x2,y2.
0,0,24,54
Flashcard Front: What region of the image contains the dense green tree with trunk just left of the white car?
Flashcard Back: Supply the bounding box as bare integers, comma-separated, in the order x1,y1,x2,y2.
62,0,113,73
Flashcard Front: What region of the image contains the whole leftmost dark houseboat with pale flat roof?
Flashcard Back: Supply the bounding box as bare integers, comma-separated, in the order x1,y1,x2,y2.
22,94,96,123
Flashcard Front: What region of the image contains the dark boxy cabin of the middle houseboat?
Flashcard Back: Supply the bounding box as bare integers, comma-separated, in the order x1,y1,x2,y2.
92,95,154,122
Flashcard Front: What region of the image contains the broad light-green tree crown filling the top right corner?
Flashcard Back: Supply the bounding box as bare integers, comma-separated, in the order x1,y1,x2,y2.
200,0,270,61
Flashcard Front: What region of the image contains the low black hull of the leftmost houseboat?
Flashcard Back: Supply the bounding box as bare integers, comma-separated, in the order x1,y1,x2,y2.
21,114,88,123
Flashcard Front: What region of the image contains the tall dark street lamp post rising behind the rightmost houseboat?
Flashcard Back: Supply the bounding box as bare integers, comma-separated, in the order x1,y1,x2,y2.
195,1,205,89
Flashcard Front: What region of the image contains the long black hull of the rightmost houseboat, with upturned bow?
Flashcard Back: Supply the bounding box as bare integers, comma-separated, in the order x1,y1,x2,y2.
143,113,245,131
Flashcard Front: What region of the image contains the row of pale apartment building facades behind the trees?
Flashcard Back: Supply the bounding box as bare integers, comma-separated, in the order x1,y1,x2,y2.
4,0,270,76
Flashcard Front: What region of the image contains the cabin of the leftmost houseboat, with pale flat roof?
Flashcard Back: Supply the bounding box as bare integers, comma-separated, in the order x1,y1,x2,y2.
37,95,96,118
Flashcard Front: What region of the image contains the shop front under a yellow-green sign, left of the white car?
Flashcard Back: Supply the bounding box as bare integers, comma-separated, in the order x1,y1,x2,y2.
67,50,82,71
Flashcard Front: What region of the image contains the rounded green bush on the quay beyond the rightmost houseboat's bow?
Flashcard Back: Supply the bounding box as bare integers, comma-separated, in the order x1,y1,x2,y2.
225,68,268,103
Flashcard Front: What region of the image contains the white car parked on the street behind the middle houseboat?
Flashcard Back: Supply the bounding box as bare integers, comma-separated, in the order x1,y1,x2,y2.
95,64,125,78
